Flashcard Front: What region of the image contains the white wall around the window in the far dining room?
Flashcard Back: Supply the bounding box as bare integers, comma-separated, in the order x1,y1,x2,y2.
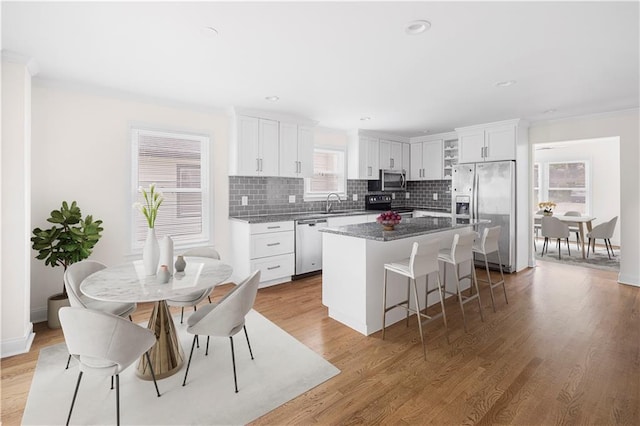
534,138,620,245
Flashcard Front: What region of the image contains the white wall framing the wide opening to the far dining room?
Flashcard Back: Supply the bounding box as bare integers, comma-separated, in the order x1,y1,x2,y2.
529,109,640,286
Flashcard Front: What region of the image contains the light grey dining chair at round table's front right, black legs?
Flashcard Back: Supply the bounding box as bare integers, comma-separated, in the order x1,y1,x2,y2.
182,270,260,393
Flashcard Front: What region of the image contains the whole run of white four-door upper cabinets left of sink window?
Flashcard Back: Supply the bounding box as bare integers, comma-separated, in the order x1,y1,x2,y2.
229,111,315,177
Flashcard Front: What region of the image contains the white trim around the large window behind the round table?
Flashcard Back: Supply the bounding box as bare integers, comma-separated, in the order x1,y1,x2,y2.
127,125,213,254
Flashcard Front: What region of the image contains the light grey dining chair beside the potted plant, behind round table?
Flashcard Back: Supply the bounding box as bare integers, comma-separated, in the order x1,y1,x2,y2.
63,260,136,368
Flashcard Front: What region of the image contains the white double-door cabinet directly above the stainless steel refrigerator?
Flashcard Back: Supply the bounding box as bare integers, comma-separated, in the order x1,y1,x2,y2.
456,123,517,163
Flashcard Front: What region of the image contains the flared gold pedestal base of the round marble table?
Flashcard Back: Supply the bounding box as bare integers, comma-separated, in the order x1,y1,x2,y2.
136,300,184,380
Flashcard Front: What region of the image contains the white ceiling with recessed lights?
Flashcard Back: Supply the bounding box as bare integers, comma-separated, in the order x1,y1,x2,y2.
2,1,640,136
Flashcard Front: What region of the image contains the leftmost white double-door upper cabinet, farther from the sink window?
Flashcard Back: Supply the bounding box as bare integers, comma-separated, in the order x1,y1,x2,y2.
229,116,279,176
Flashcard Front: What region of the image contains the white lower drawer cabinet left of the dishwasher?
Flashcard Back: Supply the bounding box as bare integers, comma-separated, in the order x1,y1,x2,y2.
230,220,295,288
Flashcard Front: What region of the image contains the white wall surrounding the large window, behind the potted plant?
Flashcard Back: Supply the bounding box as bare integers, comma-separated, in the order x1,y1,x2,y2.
31,80,230,322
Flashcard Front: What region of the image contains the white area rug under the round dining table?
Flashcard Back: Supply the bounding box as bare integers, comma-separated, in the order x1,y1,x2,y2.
22,311,340,425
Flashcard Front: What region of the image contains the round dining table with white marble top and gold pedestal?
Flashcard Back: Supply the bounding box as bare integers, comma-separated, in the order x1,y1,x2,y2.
80,256,233,380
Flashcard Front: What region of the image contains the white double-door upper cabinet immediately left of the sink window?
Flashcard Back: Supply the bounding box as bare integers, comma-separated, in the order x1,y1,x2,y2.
279,122,313,177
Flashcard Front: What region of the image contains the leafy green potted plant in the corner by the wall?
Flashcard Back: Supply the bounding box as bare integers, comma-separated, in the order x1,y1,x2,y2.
31,201,103,328
